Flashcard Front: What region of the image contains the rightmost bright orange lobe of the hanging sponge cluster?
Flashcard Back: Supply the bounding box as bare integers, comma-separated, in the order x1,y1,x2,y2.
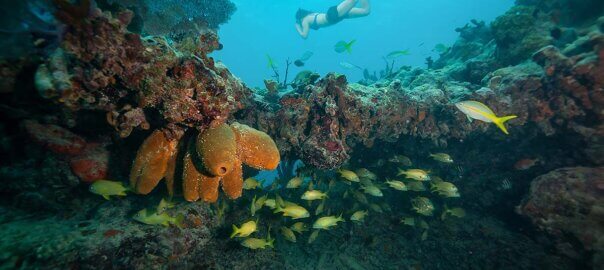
231,123,281,170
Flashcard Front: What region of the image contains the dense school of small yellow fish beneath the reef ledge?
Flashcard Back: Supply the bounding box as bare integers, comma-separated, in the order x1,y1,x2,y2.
222,150,465,249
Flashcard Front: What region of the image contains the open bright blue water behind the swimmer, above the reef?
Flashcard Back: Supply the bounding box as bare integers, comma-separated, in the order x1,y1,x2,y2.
213,0,514,87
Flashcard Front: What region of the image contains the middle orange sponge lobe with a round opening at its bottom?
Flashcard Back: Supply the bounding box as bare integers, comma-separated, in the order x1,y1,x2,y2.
196,124,237,176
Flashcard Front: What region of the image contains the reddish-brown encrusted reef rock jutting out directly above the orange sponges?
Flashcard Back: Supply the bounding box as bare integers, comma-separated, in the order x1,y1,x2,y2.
36,5,251,137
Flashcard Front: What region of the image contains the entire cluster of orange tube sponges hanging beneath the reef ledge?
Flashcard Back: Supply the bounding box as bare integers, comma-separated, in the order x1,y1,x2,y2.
130,123,280,202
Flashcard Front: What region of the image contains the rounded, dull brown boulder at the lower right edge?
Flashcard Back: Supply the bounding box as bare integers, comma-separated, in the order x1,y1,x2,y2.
518,167,604,266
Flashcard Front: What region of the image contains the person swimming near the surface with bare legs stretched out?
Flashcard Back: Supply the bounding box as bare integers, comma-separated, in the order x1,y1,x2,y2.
296,0,371,38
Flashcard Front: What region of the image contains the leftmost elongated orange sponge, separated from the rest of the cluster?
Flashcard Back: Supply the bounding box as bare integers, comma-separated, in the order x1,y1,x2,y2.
130,130,178,194
